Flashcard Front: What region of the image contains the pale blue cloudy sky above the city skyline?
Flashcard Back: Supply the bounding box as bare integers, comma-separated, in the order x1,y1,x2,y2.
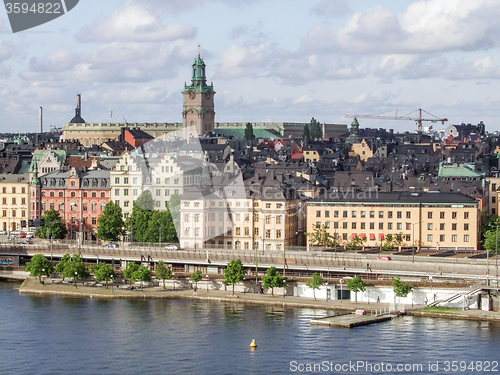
0,0,500,132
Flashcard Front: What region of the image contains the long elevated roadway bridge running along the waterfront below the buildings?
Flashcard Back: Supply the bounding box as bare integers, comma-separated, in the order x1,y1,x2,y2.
0,241,498,284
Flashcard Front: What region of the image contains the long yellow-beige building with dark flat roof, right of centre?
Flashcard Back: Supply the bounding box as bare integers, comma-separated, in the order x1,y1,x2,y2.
307,191,480,250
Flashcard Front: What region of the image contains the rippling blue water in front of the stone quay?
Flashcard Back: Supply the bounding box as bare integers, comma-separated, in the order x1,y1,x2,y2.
0,282,500,375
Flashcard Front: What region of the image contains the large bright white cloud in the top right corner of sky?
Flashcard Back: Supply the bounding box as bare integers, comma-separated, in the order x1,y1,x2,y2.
337,0,500,53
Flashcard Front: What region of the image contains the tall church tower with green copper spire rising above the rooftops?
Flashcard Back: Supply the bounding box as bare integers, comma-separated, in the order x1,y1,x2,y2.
182,53,215,139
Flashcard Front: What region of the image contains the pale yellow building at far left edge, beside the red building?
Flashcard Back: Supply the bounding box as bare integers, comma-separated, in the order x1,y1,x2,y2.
0,173,29,233
